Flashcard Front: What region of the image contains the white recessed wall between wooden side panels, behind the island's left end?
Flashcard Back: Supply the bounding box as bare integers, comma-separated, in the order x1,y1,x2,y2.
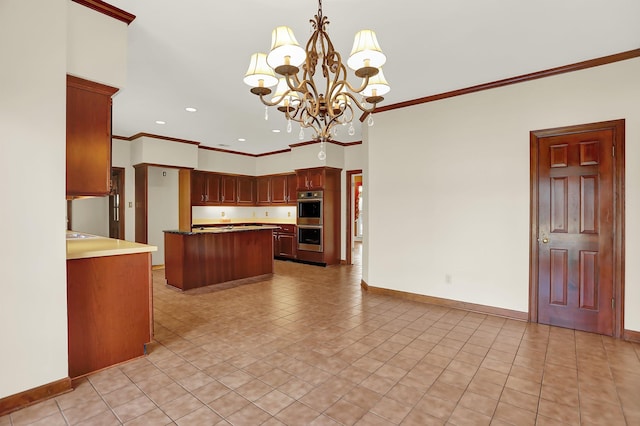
147,167,178,265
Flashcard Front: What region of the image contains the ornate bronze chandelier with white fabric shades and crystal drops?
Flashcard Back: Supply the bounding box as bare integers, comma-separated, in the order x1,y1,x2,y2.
244,0,390,160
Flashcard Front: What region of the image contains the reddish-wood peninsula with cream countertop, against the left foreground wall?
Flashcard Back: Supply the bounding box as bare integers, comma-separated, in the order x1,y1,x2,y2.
67,231,157,379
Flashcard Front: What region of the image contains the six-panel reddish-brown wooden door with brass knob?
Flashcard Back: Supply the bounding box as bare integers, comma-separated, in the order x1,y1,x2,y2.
531,120,621,335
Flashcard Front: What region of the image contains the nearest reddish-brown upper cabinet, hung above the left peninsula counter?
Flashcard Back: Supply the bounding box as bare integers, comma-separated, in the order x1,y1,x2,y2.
67,75,118,197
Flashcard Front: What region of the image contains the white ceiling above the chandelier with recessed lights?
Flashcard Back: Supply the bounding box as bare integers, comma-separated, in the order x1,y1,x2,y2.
107,0,640,154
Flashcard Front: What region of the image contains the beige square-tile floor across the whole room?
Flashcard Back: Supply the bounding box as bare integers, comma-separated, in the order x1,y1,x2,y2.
0,245,640,426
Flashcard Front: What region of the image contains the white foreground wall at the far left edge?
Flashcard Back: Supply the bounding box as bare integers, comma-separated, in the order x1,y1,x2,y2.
0,0,68,398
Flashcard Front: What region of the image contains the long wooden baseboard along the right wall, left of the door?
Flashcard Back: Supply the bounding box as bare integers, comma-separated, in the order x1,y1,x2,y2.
360,280,529,321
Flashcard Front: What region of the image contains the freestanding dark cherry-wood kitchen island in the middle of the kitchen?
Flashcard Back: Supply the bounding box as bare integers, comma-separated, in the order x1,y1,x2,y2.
164,225,278,290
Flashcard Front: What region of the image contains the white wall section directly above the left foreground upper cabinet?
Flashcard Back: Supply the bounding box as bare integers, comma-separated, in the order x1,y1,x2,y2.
67,0,127,88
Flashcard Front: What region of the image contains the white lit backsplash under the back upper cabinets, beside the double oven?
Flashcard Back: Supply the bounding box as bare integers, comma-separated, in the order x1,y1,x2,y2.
191,206,296,225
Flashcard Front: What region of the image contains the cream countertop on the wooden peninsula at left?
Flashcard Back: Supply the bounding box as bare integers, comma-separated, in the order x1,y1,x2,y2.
67,231,158,260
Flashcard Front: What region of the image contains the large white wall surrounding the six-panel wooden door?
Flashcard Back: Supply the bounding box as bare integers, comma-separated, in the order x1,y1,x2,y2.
363,55,640,330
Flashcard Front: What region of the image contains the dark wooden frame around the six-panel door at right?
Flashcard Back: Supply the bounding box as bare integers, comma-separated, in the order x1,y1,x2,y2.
529,119,625,337
